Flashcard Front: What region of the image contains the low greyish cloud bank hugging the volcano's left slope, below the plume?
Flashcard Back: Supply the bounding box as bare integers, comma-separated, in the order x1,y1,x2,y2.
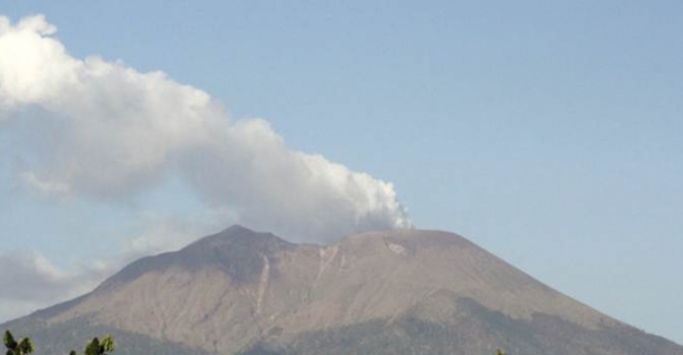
0,211,235,323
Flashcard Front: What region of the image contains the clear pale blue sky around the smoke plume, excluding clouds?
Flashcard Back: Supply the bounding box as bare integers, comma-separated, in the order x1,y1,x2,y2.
0,1,683,343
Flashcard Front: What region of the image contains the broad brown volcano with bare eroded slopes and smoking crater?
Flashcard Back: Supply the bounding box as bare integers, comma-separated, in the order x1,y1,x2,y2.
2,226,683,355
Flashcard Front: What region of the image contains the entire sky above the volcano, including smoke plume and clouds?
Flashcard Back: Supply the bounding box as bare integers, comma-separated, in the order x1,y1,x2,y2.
0,0,683,343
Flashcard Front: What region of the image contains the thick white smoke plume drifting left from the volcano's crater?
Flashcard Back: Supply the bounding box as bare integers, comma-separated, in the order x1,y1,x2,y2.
0,15,410,241
